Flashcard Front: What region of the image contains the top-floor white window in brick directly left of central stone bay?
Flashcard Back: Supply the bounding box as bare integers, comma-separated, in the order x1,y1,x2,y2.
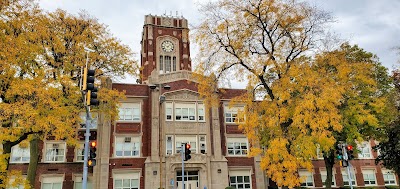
119,103,141,122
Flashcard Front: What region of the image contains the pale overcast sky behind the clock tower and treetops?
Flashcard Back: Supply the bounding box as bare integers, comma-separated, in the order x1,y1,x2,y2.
39,0,400,83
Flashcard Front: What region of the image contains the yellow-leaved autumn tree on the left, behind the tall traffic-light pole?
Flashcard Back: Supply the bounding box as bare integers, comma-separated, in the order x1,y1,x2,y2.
0,0,137,188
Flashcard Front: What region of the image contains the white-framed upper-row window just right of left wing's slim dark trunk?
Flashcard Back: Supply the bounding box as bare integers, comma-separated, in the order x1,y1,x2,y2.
43,141,67,163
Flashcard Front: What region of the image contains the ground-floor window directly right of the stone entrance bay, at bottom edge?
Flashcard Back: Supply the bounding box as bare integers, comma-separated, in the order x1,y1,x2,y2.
229,170,251,189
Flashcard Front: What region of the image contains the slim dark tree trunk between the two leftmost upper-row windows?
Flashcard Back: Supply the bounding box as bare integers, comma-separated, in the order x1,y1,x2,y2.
27,136,39,189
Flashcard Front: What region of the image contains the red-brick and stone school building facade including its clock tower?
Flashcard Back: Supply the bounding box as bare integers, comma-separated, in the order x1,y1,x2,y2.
6,15,398,189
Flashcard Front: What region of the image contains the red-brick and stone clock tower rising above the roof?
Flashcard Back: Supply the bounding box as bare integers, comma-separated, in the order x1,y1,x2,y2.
141,15,191,83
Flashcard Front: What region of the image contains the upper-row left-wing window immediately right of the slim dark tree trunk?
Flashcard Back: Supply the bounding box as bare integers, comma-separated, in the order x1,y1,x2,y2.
45,142,66,162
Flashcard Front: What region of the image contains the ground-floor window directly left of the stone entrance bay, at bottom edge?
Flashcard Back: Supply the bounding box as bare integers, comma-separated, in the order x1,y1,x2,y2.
113,172,140,189
